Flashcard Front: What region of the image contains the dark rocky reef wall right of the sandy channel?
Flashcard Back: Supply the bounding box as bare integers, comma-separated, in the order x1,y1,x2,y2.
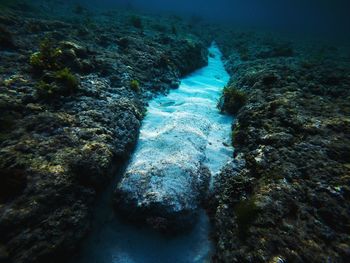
211,31,350,262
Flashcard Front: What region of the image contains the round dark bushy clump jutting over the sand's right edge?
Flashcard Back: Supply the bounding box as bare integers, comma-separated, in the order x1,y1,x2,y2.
218,86,247,114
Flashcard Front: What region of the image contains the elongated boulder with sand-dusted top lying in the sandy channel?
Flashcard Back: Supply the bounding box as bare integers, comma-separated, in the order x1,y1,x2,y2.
115,114,210,231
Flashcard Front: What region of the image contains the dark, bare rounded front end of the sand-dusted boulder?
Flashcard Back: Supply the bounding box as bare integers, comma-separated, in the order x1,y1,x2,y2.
115,160,210,232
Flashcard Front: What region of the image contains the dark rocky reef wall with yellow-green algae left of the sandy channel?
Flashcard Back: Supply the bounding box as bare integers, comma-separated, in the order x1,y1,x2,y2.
0,4,207,263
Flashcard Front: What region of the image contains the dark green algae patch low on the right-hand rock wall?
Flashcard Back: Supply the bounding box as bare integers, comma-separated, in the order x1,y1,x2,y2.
234,198,259,240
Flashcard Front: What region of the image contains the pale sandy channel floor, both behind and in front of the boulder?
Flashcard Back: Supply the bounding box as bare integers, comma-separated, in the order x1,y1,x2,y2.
72,44,233,263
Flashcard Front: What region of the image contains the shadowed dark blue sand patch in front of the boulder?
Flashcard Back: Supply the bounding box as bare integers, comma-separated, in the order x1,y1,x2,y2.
72,211,212,263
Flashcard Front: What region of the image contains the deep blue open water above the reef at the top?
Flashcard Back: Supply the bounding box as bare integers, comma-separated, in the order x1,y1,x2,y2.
76,0,350,37
